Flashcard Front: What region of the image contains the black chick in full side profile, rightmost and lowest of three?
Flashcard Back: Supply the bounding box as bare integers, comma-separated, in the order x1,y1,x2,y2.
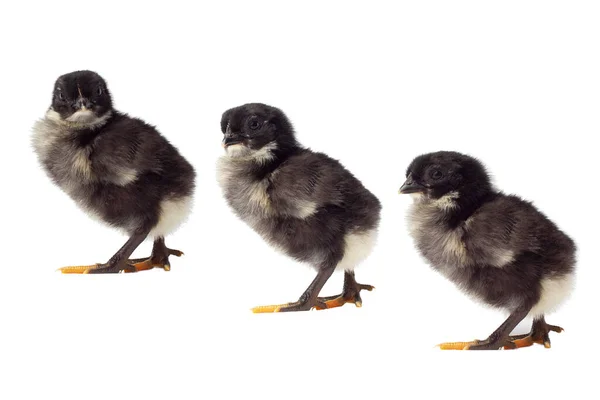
400,151,575,350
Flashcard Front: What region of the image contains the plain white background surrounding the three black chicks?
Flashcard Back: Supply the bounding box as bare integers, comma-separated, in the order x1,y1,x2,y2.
0,1,600,399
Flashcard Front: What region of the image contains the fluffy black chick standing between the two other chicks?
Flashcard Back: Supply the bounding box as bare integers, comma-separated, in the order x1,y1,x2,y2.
218,104,381,312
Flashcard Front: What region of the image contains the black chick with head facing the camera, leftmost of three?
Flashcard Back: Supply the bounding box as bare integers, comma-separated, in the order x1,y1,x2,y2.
33,71,195,273
